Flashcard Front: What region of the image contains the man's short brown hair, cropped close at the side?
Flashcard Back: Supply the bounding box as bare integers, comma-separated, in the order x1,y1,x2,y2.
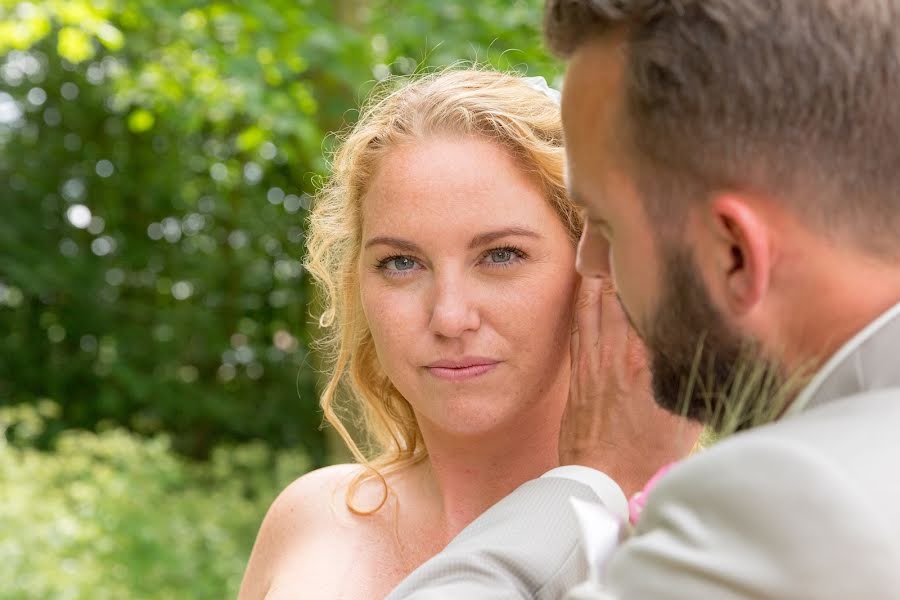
545,0,900,256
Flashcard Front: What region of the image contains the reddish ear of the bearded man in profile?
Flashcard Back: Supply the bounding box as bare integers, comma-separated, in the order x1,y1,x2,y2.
709,194,772,316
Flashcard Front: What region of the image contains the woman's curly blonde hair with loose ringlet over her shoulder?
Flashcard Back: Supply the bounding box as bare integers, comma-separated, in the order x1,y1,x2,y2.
305,68,581,514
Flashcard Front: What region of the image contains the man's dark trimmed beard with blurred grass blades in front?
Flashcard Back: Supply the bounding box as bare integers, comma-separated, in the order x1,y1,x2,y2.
644,245,796,434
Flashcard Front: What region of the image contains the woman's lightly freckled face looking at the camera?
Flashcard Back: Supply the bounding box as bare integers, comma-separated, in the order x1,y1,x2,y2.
359,138,576,434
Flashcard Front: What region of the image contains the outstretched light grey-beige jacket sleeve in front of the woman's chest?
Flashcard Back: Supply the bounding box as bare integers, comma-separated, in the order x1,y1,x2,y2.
388,477,599,600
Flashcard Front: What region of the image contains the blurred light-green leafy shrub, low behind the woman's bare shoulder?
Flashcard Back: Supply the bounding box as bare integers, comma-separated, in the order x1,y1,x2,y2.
0,402,309,600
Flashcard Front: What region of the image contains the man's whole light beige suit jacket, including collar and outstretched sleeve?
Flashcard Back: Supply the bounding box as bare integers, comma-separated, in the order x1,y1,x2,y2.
389,305,900,600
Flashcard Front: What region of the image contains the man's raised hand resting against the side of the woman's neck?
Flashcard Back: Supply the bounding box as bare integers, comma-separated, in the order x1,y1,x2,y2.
559,278,702,496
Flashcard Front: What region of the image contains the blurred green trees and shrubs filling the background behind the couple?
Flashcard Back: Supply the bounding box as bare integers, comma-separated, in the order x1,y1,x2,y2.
0,0,561,599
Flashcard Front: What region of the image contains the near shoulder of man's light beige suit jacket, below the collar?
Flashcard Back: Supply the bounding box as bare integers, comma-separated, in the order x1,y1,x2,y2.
606,389,900,599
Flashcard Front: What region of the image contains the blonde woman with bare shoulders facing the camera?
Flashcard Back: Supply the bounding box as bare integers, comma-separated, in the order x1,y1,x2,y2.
240,70,580,600
